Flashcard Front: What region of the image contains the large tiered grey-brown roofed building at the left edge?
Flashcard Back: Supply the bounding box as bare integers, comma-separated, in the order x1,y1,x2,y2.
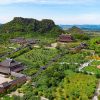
0,59,24,74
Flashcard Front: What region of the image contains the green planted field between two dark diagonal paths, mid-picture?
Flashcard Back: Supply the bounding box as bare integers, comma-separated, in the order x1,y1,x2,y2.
16,48,58,75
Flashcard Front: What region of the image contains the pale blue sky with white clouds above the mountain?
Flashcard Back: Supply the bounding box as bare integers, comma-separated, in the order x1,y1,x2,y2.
0,0,100,25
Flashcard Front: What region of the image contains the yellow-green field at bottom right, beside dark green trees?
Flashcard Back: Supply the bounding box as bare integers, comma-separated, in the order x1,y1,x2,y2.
55,71,97,100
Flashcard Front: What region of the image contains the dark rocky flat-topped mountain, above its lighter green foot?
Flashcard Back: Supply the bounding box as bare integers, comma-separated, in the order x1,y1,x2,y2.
0,17,57,33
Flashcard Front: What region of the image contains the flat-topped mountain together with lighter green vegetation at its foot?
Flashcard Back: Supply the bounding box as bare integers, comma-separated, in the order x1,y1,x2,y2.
0,17,63,44
